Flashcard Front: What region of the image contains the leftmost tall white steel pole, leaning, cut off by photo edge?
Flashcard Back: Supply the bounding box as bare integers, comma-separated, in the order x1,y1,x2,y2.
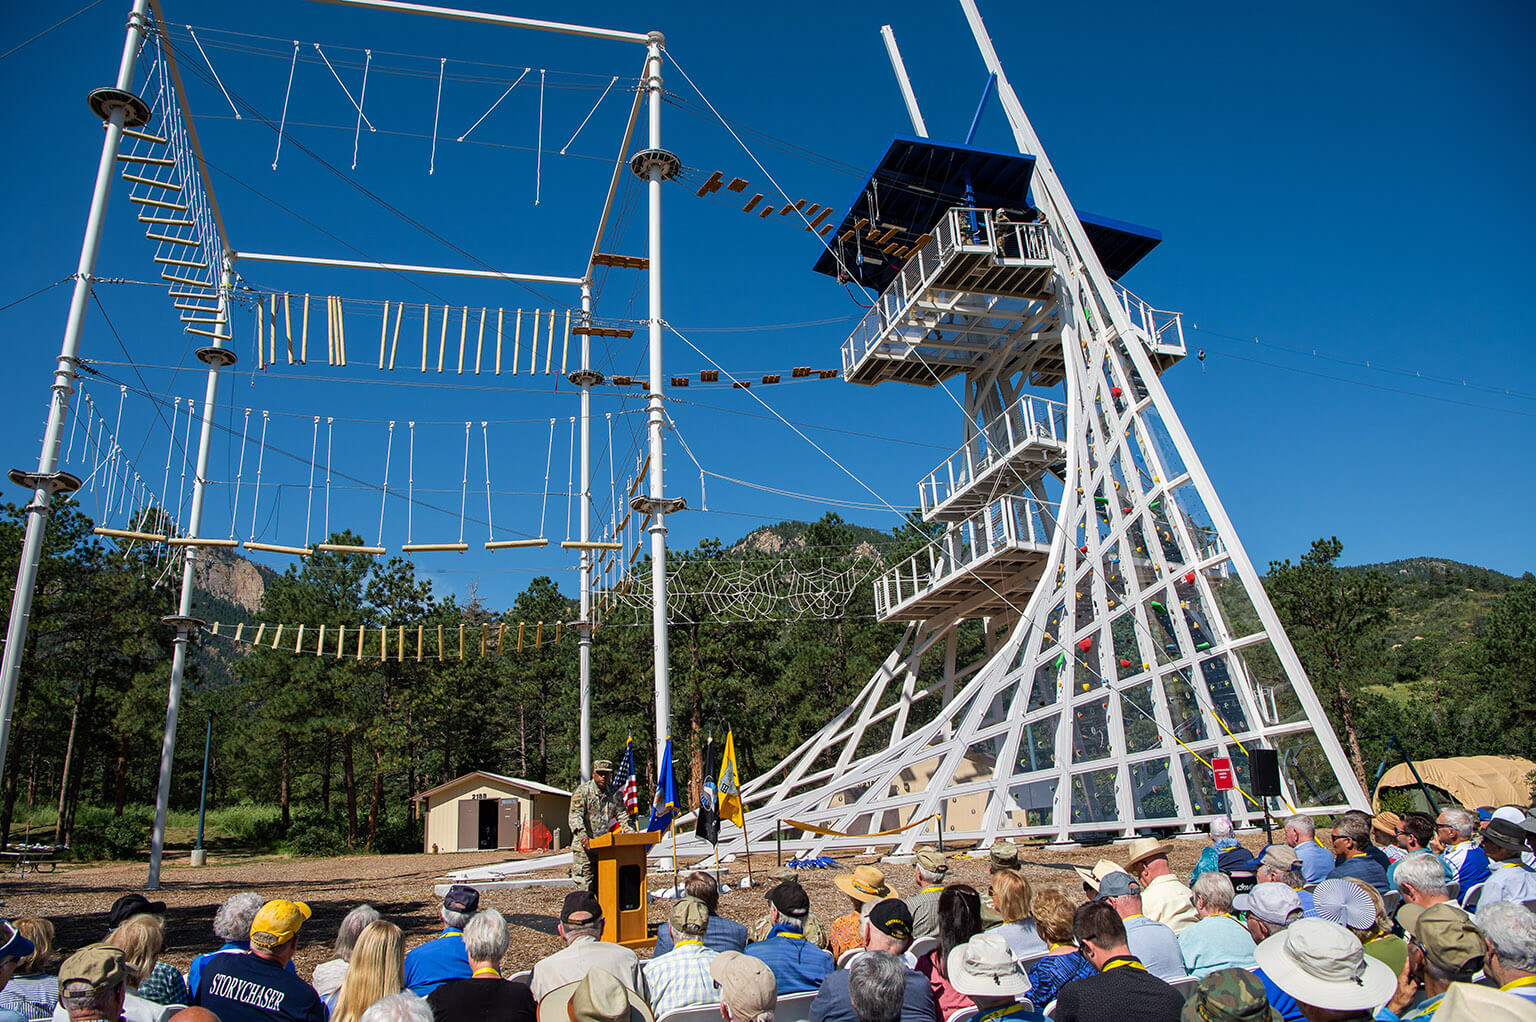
0,0,149,799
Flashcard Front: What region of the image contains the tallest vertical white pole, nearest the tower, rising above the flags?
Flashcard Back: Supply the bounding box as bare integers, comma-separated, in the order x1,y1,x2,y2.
645,32,671,756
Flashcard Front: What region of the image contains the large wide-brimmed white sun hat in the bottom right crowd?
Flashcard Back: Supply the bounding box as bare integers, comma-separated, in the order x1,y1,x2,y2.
1253,919,1398,1022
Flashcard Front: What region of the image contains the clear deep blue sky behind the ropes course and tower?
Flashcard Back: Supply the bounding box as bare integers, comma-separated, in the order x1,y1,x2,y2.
0,0,1536,604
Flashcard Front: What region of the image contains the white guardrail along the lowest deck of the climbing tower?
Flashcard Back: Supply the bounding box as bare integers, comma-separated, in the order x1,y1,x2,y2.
874,496,1055,618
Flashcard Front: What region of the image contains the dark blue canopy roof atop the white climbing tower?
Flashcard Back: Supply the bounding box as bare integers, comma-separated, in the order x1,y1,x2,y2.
813,135,1163,290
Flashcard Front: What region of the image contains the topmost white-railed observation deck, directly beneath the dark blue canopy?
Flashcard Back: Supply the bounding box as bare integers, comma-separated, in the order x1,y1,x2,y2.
843,206,1054,387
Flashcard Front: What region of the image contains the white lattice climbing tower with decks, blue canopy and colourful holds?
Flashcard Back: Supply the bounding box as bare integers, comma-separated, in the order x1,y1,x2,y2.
722,3,1364,851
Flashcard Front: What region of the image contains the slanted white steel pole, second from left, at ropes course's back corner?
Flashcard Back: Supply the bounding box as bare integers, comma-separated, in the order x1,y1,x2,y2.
144,257,235,891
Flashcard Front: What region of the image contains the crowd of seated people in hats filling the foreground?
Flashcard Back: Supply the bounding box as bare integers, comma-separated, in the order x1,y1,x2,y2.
0,807,1536,1022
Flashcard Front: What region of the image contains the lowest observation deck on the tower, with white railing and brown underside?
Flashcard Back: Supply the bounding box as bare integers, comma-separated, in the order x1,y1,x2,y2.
874,496,1055,621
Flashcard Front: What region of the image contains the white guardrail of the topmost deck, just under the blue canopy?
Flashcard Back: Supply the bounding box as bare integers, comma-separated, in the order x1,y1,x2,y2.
843,206,1051,378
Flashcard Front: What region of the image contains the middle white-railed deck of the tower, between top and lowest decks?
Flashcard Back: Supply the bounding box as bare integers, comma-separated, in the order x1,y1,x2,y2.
917,395,1066,521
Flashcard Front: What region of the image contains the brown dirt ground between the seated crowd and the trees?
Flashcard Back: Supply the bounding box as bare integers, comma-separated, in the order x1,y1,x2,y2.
0,833,1264,977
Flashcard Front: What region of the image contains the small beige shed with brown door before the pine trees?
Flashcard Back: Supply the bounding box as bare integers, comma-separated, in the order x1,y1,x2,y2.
413,770,571,853
